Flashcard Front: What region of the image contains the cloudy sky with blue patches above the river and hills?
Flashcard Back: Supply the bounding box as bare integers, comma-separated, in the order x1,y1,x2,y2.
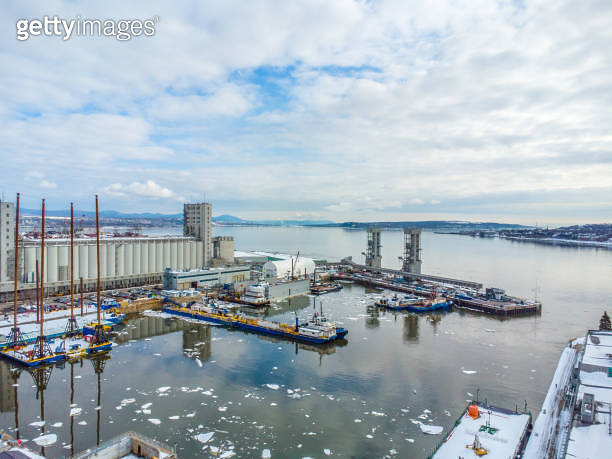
0,0,612,224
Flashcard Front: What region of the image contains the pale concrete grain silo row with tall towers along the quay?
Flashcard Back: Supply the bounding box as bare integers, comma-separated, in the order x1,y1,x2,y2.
0,202,234,296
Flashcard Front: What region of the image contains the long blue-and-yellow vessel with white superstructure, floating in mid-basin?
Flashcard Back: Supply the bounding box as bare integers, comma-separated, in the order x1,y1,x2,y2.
163,303,348,344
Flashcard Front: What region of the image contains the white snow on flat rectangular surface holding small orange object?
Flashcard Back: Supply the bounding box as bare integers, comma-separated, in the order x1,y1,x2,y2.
433,407,530,459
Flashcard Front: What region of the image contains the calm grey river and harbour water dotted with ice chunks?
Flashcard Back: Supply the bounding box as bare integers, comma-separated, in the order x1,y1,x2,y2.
0,227,612,458
